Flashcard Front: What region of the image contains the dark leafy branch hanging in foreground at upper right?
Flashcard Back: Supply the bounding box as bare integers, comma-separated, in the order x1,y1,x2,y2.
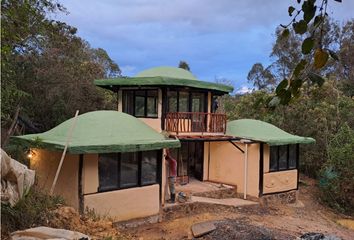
270,0,341,105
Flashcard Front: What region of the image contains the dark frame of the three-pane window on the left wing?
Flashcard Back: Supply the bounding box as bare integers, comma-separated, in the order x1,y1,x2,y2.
97,150,162,193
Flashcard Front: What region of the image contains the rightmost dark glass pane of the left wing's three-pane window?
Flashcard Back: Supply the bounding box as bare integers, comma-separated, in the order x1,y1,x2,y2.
141,151,157,185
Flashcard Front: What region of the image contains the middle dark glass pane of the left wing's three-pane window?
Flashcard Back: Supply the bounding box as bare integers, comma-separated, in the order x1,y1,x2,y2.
120,153,138,188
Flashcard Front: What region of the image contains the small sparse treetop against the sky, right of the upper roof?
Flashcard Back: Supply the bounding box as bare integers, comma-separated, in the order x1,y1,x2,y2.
247,63,276,90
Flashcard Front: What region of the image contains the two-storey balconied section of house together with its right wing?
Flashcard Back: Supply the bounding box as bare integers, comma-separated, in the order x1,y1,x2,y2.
95,67,314,199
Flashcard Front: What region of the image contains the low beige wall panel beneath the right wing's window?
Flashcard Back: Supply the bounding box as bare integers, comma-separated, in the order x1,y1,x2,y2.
263,169,298,194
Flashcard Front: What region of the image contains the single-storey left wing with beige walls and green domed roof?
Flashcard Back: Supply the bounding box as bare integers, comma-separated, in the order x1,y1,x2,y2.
12,111,180,221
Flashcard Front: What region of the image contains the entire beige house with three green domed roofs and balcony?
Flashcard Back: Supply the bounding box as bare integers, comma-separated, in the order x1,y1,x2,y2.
15,67,314,221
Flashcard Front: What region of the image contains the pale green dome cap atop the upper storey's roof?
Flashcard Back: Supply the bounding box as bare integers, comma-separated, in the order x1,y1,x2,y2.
135,67,197,80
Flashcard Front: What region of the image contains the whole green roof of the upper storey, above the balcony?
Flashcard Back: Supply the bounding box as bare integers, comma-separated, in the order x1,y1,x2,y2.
94,67,233,93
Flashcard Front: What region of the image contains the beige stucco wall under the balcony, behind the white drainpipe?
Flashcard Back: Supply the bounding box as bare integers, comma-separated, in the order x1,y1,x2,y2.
204,142,259,197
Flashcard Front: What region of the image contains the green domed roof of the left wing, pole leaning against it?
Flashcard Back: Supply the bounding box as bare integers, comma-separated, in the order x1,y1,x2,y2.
13,111,179,153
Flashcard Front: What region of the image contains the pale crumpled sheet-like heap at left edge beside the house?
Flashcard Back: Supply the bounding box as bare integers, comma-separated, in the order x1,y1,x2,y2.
0,149,35,206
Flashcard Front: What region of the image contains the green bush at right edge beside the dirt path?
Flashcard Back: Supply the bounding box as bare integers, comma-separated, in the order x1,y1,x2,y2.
319,124,354,214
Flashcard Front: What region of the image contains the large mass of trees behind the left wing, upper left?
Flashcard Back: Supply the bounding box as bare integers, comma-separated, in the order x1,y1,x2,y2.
1,0,120,131
